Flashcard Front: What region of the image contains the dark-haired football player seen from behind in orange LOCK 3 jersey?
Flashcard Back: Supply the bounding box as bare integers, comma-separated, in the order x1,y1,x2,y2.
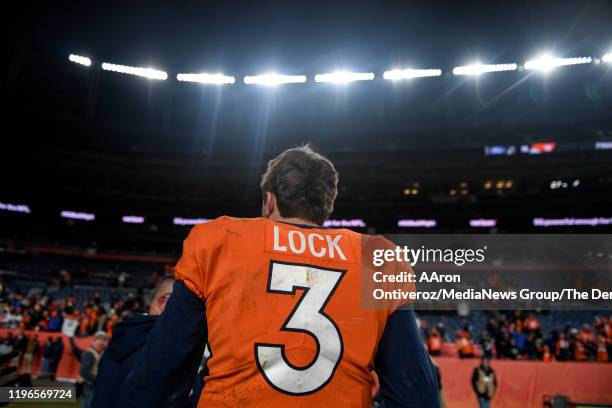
121,146,439,408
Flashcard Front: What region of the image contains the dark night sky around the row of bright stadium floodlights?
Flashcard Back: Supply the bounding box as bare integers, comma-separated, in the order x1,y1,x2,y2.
2,0,612,157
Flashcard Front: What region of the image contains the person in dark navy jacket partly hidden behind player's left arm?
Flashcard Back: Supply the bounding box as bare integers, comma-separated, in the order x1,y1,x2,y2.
92,276,182,408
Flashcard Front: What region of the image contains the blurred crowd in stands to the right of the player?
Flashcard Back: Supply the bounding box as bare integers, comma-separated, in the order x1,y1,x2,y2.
422,310,612,362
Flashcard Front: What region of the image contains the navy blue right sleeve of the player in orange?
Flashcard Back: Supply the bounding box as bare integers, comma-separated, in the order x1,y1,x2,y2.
374,310,440,408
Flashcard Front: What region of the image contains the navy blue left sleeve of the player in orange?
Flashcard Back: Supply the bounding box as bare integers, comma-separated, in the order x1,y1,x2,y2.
119,281,208,408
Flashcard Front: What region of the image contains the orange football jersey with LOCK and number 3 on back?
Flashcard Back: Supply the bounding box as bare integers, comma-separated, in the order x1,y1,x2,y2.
175,217,402,408
